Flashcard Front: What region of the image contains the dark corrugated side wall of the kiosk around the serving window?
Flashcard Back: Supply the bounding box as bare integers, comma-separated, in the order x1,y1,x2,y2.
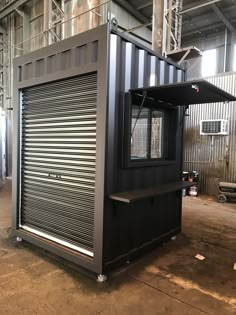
104,34,184,269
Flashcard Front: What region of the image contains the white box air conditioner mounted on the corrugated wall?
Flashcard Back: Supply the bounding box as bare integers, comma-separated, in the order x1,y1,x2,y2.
200,119,229,136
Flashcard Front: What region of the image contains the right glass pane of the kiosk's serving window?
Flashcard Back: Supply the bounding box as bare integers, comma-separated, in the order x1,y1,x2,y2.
151,111,164,159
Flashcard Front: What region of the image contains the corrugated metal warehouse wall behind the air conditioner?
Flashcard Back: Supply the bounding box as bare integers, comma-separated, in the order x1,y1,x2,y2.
184,73,236,195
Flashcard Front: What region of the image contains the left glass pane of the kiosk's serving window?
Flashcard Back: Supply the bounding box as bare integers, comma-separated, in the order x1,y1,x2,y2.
131,105,150,160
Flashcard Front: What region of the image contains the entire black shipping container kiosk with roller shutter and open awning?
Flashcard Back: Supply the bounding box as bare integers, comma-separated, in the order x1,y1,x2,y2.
12,24,235,281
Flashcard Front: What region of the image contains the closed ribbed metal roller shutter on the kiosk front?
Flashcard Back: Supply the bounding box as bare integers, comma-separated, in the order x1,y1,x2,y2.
21,74,97,251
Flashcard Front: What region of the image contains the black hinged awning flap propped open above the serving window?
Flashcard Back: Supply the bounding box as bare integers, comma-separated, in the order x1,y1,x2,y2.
130,80,236,106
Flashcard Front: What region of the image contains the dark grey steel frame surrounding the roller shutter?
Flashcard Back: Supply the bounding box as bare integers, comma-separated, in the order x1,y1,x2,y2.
12,24,110,274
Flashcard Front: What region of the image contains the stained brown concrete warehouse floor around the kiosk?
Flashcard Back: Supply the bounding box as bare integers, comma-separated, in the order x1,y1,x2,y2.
0,184,236,315
